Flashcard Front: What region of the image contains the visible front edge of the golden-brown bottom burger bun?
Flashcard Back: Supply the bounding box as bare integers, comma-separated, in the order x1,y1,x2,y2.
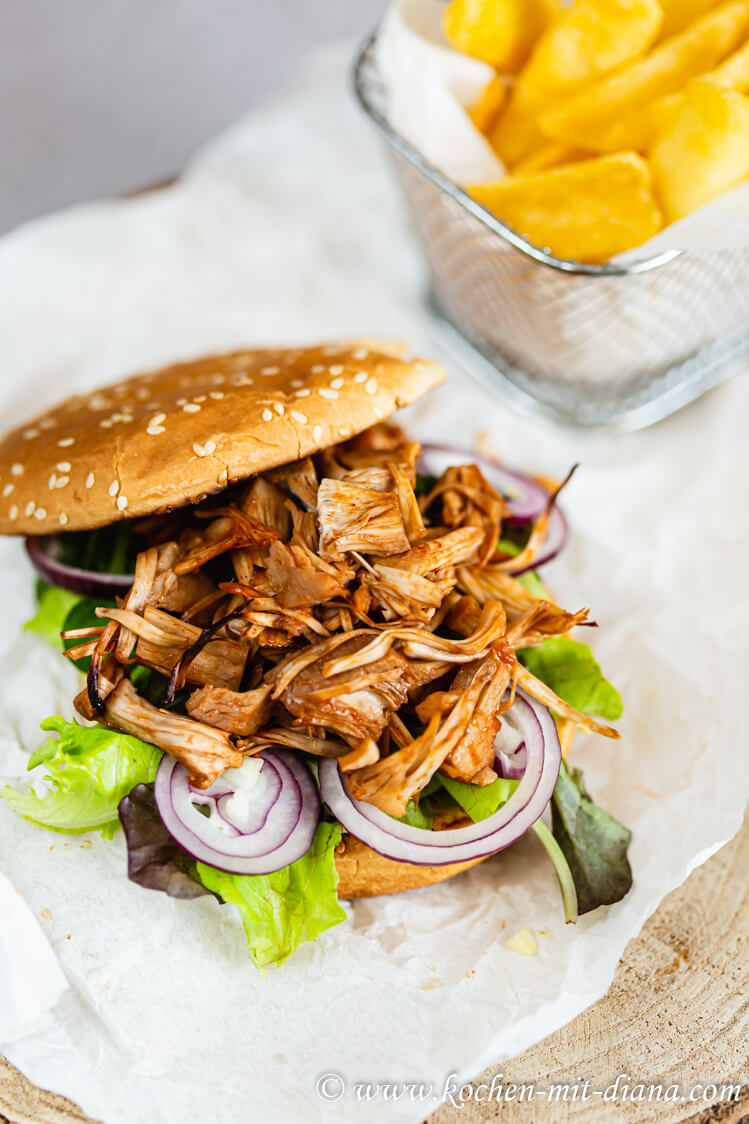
335,835,482,898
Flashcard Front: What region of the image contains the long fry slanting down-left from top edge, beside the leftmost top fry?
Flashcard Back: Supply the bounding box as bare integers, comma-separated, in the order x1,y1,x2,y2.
491,0,664,167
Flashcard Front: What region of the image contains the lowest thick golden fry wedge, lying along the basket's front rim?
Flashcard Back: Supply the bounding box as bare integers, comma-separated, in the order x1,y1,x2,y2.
467,153,661,262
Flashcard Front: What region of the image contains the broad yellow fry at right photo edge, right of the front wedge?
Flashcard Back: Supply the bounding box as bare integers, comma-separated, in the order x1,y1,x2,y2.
650,80,749,223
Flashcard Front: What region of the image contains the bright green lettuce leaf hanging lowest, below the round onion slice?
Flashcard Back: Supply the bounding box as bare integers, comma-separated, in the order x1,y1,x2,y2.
197,823,346,968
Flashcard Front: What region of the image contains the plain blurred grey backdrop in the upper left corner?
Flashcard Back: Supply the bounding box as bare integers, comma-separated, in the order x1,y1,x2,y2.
0,0,386,232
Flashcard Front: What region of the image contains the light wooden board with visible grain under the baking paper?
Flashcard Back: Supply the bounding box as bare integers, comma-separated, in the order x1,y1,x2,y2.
0,814,749,1124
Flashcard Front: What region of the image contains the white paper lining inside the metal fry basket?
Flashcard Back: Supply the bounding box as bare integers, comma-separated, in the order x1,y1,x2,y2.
377,0,749,262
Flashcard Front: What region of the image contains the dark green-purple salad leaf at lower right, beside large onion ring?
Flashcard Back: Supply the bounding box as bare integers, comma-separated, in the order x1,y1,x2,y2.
551,763,632,914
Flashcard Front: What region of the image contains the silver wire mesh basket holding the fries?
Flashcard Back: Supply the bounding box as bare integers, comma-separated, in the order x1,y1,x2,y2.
354,35,749,428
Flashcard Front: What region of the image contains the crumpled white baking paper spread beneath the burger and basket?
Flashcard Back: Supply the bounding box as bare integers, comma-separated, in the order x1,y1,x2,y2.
0,39,749,1124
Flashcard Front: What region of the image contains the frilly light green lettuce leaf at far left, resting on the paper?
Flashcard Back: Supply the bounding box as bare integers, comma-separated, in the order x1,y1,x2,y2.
0,715,162,839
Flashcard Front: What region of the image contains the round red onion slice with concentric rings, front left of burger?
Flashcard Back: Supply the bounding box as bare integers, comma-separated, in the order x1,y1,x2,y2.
154,750,319,874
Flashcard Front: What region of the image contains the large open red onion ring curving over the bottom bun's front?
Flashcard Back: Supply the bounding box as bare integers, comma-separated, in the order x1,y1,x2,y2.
318,689,561,867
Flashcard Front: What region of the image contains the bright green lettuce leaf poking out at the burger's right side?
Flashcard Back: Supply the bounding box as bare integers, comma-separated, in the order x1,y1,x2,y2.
517,636,622,722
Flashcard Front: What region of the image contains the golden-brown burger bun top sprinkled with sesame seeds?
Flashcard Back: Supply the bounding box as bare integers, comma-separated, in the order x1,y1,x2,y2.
0,344,444,535
